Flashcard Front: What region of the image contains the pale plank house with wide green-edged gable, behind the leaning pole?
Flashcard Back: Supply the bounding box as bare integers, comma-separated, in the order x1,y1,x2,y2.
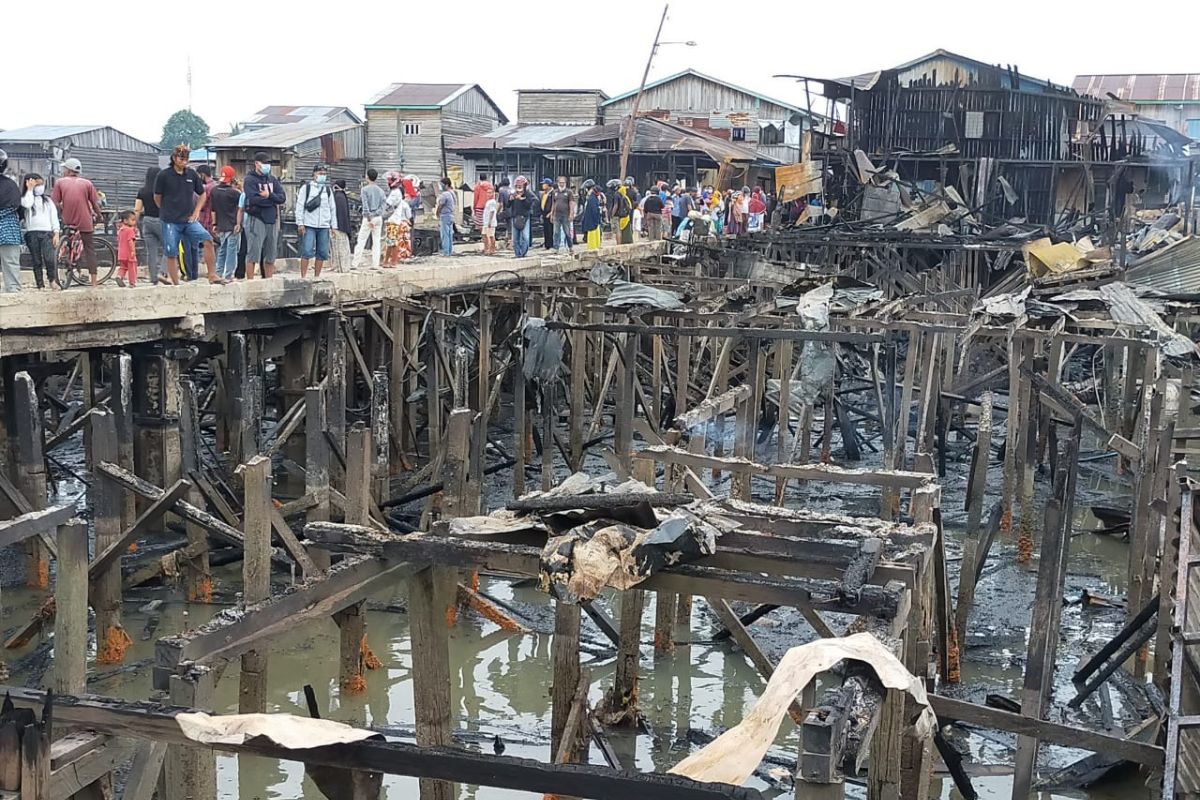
600,70,818,163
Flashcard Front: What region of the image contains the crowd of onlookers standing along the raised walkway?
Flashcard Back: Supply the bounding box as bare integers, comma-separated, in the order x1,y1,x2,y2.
0,145,790,291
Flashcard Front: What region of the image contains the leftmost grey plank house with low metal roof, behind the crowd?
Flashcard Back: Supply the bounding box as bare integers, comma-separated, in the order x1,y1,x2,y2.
0,125,162,211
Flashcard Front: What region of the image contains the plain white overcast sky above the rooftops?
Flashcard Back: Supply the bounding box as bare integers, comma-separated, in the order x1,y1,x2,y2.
7,0,1200,142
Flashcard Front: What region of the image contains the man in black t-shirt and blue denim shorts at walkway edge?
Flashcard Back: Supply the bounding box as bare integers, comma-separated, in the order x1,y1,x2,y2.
154,144,224,285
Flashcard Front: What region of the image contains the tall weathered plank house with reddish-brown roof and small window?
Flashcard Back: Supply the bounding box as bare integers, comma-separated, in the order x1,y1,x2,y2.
357,83,509,185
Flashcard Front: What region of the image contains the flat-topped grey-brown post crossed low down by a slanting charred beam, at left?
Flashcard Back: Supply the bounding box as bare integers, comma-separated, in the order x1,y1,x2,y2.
238,456,271,714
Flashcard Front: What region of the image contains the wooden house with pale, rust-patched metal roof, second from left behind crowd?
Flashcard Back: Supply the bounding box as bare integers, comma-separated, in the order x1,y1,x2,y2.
208,121,367,219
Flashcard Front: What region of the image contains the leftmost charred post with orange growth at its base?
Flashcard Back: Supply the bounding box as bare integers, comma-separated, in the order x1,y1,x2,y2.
91,410,132,664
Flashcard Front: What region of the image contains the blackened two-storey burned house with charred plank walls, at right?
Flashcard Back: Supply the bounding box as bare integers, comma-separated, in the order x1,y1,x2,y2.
818,50,1192,227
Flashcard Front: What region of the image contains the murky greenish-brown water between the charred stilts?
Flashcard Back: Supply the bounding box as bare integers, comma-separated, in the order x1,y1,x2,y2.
0,431,1151,800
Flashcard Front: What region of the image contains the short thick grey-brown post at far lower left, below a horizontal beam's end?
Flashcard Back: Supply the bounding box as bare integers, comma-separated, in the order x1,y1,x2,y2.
53,519,88,695
